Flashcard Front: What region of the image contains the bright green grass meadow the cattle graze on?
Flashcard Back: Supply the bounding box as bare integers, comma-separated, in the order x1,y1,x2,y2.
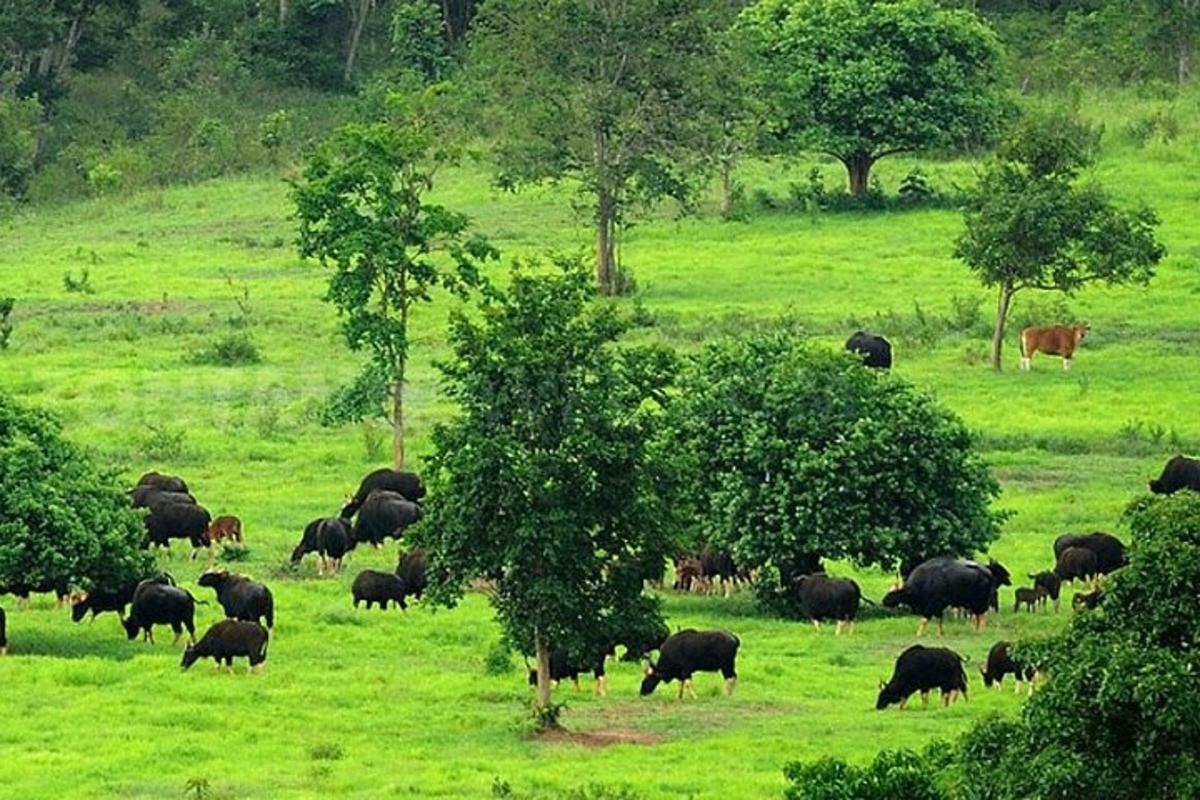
0,98,1200,799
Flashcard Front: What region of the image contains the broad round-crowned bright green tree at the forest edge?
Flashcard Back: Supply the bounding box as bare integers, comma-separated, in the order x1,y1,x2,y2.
739,0,1003,196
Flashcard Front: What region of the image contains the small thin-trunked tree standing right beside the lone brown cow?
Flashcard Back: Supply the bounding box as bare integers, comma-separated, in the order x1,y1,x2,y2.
954,112,1165,369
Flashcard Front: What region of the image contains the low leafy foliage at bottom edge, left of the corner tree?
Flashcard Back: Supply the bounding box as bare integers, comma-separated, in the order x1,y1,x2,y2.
784,750,949,800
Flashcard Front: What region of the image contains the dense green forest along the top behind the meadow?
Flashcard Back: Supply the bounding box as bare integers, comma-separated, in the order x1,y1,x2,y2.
0,0,1200,209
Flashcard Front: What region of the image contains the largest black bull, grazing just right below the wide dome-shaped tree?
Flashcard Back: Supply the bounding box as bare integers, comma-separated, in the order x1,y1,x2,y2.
883,557,995,636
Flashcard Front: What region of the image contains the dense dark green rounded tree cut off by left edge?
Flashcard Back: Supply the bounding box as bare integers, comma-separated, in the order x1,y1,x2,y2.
0,395,154,604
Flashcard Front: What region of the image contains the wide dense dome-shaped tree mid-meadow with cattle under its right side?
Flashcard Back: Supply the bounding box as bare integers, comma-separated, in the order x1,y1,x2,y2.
664,326,1003,612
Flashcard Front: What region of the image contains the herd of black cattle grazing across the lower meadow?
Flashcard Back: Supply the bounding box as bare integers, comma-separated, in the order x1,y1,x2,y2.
0,456,1200,709
